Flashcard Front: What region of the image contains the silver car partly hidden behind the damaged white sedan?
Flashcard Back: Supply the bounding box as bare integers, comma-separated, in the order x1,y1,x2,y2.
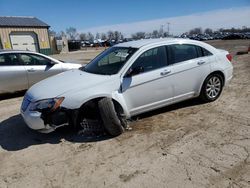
0,50,81,94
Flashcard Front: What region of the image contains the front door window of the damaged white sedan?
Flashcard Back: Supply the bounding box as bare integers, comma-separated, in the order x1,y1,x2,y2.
131,46,167,72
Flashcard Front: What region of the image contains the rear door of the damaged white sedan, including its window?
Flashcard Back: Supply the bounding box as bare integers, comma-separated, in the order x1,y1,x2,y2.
167,44,212,101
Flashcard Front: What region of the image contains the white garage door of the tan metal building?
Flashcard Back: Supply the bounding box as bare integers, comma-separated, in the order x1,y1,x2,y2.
10,33,38,52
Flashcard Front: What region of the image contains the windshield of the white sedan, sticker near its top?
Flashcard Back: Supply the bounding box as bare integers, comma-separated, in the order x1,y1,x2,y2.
80,47,137,75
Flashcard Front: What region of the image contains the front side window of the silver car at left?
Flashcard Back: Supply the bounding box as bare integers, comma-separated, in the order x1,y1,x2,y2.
20,54,50,65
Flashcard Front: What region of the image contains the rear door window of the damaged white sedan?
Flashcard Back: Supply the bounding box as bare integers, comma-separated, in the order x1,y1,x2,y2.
168,44,199,64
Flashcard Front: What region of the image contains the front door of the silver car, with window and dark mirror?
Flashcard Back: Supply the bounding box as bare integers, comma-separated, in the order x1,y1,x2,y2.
19,53,63,87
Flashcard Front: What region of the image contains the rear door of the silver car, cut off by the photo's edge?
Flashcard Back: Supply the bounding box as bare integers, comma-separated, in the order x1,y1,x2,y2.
0,53,28,93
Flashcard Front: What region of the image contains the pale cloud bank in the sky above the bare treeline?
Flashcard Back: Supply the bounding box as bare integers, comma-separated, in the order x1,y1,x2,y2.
81,6,250,36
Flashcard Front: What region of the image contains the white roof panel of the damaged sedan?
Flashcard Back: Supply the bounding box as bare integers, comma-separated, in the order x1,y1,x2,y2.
115,38,190,48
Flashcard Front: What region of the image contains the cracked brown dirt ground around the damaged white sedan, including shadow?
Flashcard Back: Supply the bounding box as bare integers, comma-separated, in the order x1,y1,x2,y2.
0,40,250,188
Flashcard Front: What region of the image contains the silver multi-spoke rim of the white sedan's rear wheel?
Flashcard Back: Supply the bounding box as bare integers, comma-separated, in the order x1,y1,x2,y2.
206,76,221,99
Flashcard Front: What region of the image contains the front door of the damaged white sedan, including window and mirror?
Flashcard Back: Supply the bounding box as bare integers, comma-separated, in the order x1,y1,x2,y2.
122,46,173,115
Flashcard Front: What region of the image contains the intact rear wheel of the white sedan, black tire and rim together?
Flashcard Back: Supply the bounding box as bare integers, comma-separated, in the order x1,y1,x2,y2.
199,74,223,102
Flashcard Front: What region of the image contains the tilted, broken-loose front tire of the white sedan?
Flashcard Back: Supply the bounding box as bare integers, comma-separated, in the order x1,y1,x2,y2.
98,98,124,136
